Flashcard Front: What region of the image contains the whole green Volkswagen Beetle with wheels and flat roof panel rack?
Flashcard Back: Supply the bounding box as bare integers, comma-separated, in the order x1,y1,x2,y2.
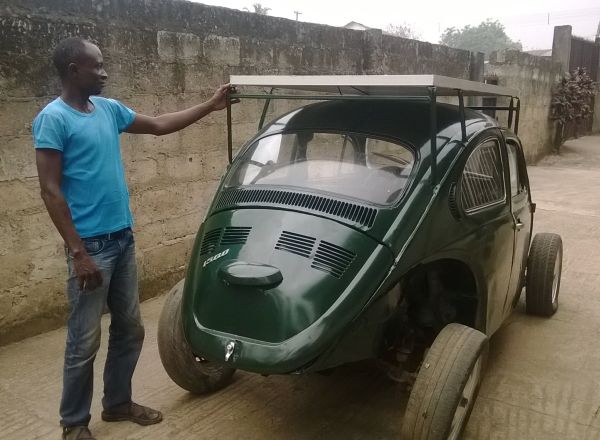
158,75,562,440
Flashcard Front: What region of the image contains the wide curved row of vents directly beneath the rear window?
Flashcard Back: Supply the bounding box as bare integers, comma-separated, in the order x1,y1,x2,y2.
215,189,377,228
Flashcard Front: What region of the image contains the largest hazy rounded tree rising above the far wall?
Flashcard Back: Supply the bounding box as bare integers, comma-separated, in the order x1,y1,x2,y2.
440,19,523,59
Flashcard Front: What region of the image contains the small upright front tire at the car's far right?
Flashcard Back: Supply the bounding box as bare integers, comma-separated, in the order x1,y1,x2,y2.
525,233,563,317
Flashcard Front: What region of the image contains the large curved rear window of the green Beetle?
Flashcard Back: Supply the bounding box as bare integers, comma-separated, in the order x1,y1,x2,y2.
225,131,414,205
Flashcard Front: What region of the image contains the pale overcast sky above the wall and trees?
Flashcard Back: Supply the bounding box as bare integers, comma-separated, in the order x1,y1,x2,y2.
189,0,600,50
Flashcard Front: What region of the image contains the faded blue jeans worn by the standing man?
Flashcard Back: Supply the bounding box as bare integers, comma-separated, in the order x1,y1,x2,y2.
60,229,144,426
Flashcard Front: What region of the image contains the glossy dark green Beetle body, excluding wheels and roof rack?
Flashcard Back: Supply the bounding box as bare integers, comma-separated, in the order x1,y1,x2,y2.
181,100,534,374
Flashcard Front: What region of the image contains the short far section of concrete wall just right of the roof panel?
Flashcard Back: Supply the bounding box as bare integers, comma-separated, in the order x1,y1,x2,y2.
485,50,562,162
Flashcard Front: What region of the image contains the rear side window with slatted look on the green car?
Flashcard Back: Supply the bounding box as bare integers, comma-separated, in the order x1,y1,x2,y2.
460,139,506,212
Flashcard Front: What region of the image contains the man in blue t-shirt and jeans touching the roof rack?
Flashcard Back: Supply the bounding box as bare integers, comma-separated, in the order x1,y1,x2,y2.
33,38,228,440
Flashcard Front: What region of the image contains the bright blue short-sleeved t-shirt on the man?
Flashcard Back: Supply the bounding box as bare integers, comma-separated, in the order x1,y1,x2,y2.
33,96,135,238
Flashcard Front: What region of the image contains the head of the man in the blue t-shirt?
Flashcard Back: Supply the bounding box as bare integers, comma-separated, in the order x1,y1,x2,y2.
69,43,108,95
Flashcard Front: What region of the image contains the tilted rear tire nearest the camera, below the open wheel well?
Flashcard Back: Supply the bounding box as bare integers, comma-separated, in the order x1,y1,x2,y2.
401,324,488,440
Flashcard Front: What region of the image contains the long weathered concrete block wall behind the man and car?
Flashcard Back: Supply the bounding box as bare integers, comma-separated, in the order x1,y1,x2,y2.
0,0,483,344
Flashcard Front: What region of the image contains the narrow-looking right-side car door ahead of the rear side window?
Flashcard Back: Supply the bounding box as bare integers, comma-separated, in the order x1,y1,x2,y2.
504,136,533,315
